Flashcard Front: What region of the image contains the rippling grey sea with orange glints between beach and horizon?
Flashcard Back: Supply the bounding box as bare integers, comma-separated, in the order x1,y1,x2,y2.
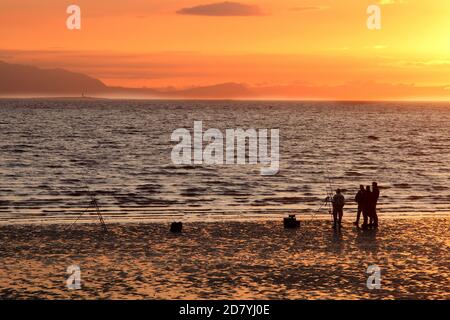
0,98,450,224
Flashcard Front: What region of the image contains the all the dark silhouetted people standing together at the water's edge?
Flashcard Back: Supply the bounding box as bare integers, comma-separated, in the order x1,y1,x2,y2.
331,182,380,229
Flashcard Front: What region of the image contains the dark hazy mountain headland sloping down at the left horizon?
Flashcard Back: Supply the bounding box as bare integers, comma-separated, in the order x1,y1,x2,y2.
0,61,108,96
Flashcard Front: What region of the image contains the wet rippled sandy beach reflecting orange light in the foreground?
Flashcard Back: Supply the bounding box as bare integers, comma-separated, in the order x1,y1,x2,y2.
0,217,450,299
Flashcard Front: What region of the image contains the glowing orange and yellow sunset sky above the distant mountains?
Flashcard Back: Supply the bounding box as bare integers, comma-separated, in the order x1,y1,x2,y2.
0,0,450,99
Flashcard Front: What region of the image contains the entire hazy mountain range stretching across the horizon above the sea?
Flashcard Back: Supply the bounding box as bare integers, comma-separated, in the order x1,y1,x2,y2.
0,61,450,100
